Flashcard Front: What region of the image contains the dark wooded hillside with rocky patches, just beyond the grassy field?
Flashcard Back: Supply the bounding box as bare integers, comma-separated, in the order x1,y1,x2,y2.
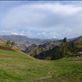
25,37,82,60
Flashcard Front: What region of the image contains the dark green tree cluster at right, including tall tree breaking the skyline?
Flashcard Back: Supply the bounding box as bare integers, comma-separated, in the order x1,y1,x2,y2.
61,38,82,56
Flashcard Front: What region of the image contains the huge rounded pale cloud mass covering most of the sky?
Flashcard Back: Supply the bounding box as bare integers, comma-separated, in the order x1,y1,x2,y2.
1,3,82,38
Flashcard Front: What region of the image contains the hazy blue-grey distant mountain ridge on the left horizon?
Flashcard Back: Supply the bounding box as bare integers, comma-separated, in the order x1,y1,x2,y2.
0,35,58,46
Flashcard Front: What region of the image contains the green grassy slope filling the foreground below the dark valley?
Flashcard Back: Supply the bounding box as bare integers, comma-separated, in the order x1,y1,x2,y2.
0,49,82,82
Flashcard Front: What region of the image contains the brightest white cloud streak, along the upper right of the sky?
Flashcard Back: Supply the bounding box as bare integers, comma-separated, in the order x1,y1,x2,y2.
33,3,82,15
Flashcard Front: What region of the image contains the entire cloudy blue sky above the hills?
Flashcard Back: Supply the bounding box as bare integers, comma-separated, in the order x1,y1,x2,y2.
0,1,82,39
